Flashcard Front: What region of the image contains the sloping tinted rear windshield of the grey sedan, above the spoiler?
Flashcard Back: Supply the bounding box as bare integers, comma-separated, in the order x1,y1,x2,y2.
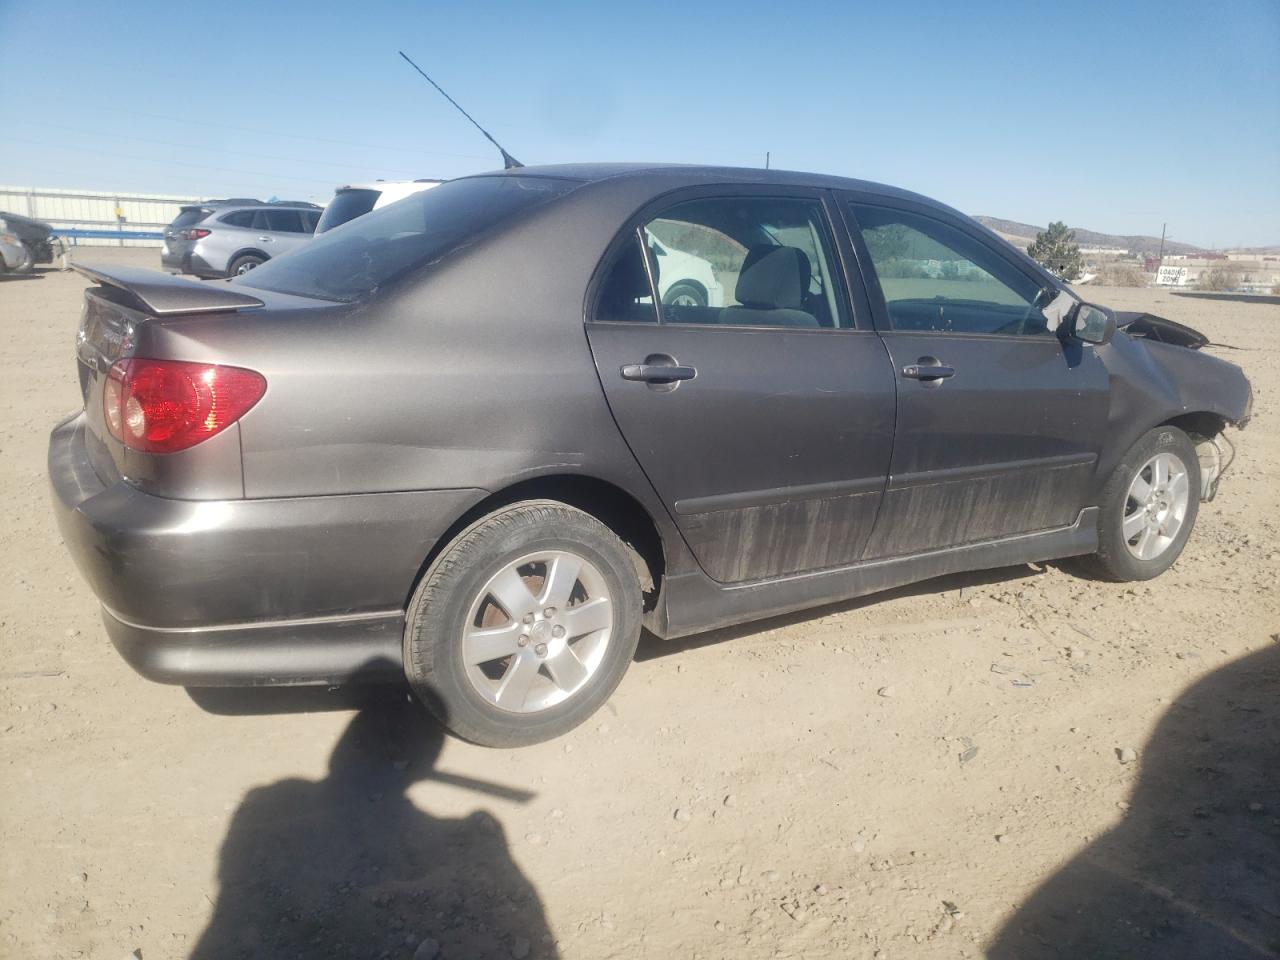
234,175,577,302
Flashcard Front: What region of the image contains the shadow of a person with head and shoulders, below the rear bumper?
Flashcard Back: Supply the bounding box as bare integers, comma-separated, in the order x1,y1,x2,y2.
191,696,556,960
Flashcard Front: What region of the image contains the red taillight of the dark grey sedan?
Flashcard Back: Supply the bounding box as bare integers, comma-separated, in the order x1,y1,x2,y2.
102,360,266,453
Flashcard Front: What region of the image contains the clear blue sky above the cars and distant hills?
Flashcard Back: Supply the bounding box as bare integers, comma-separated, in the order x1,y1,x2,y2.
0,0,1280,247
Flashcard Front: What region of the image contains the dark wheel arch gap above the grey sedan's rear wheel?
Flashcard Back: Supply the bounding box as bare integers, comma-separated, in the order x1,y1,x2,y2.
404,474,667,613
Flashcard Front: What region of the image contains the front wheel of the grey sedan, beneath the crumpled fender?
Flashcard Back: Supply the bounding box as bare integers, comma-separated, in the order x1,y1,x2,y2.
1085,426,1201,582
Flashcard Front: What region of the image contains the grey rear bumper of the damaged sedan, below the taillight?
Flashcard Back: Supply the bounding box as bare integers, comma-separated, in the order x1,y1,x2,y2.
49,415,484,686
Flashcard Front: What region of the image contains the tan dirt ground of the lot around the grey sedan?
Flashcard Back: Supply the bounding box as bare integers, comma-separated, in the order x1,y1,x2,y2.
0,251,1280,960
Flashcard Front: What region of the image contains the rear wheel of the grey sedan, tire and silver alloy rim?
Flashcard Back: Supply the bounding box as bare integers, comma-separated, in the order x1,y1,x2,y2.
404,500,641,746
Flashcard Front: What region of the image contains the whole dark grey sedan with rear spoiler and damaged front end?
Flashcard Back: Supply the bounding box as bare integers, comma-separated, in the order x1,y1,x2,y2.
49,165,1253,745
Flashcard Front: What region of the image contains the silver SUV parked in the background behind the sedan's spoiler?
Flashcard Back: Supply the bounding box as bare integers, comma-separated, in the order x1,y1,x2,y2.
160,200,321,278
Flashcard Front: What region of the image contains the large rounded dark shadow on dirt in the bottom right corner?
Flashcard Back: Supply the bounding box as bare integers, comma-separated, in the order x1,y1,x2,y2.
987,646,1280,960
